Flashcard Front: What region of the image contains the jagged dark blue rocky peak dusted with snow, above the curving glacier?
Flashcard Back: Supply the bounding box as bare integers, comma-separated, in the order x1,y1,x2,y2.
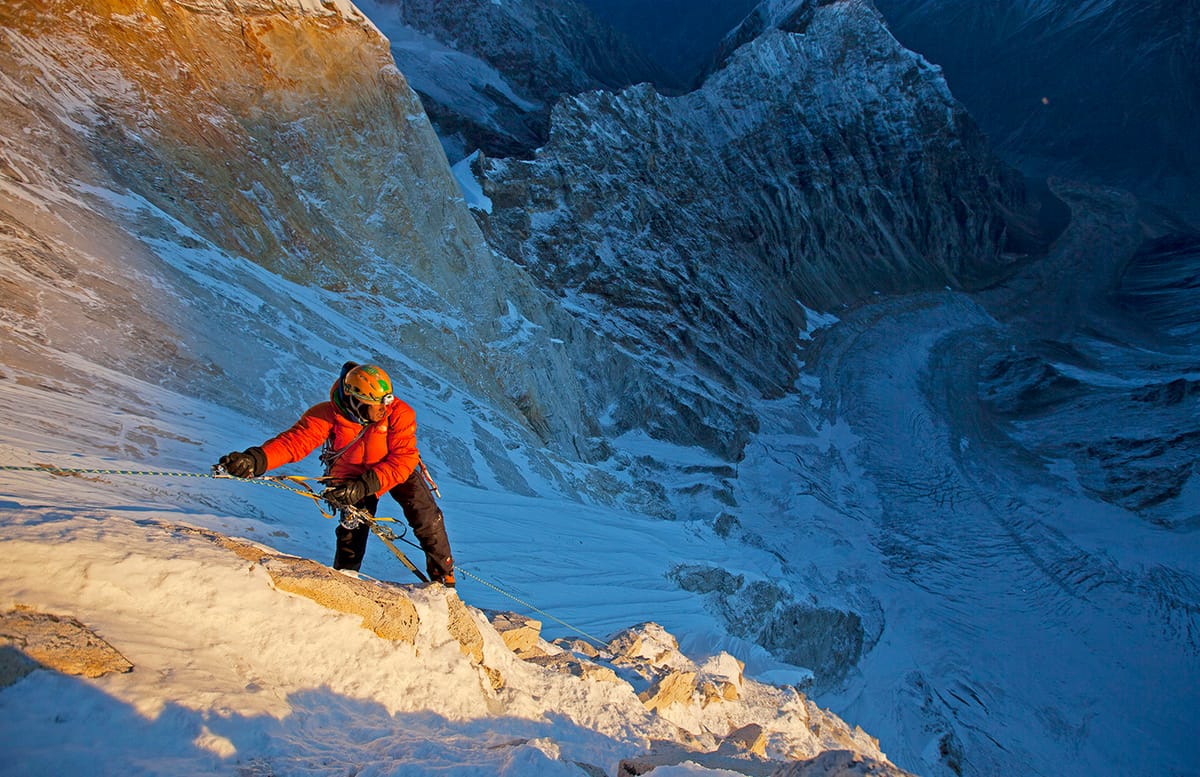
476,0,1041,454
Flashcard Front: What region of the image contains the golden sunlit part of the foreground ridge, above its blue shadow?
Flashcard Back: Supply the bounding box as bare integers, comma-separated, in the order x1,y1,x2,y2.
0,507,907,775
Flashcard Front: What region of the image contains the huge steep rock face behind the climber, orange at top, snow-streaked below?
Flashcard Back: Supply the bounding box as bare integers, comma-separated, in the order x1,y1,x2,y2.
0,0,619,458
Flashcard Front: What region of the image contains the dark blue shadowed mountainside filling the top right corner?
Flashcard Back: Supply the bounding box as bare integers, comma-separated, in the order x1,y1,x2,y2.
876,0,1200,229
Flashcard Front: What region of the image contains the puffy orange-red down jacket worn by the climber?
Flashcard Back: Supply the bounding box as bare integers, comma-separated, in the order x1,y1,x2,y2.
262,399,421,495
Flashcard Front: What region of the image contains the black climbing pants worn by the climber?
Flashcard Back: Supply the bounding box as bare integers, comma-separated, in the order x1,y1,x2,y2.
334,469,454,582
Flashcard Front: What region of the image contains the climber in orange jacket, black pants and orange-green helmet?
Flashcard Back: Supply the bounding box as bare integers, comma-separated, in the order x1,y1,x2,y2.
217,362,455,588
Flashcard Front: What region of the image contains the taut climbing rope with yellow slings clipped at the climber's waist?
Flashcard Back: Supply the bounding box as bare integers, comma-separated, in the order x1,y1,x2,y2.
0,460,607,648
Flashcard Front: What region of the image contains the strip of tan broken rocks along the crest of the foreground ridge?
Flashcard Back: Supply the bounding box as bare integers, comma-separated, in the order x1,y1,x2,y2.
184,526,902,775
